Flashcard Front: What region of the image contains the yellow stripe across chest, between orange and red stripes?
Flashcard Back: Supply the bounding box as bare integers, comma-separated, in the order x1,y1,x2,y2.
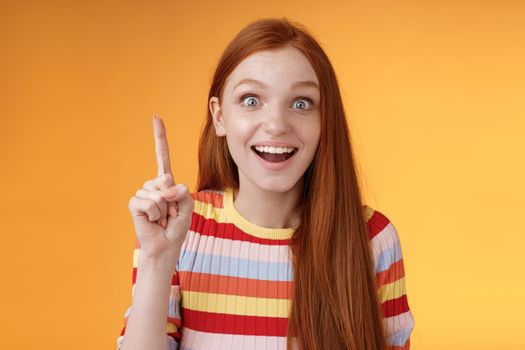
181,290,291,317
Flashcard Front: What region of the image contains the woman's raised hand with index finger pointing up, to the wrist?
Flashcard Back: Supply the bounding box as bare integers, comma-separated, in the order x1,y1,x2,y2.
128,115,194,263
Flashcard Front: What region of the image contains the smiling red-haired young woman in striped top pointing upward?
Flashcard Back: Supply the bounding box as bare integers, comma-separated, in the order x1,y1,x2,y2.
117,19,414,350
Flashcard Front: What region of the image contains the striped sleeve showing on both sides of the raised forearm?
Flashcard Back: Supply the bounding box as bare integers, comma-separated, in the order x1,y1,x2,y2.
117,240,182,350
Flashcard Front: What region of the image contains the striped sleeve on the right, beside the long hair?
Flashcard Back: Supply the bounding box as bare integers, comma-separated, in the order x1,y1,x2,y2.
367,208,414,350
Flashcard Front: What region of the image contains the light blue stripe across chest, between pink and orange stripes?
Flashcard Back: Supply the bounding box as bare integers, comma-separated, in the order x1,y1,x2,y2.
179,251,293,281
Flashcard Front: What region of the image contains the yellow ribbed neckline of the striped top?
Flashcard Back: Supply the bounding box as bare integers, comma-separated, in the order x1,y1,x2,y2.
223,187,295,239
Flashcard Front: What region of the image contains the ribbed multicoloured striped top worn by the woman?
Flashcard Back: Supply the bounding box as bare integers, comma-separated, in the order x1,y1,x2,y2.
117,188,414,350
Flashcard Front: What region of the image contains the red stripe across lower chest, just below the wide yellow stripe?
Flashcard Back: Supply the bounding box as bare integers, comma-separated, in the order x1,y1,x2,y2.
182,308,288,337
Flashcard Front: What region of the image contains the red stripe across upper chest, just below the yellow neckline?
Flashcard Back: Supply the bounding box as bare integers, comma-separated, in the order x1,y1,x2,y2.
190,212,290,245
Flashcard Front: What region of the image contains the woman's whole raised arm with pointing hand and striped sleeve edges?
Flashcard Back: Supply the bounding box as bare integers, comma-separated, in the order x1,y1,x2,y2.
118,117,194,350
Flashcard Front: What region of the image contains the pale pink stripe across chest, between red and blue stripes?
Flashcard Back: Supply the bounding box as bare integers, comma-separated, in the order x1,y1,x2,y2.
183,231,292,263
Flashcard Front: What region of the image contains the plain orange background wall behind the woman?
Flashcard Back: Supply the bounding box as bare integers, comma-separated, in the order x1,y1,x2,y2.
0,0,525,350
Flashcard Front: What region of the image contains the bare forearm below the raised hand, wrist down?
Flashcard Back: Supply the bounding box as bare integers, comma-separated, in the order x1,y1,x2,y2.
122,255,174,350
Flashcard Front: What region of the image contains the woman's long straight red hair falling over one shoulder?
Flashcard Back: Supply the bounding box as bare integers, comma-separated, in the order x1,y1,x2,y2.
197,18,386,350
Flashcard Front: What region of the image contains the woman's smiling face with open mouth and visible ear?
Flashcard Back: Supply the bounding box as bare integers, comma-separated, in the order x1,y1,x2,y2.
209,47,321,192
